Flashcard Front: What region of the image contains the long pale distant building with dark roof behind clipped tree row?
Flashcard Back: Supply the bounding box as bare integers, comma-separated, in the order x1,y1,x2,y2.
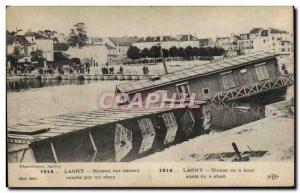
133,36,178,50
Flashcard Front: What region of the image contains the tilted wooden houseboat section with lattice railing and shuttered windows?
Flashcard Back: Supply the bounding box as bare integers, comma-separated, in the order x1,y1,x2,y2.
116,52,293,102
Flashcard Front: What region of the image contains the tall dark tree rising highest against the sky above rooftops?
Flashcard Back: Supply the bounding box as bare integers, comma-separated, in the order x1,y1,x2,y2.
67,22,88,47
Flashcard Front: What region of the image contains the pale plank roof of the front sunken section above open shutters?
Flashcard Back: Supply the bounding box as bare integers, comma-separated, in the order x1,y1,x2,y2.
7,107,185,144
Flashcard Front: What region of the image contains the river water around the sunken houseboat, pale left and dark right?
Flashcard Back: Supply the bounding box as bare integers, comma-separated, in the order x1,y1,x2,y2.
7,76,293,129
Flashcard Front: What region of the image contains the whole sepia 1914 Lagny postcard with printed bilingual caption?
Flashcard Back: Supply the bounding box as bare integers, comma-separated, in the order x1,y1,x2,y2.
6,6,296,188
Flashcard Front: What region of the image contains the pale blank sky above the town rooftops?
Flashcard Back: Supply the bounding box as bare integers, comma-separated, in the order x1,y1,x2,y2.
6,7,293,38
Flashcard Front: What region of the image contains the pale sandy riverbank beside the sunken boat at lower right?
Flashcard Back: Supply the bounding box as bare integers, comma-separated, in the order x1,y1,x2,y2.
136,101,294,162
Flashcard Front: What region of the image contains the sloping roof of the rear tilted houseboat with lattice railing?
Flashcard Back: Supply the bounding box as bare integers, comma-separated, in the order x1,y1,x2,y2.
116,51,276,93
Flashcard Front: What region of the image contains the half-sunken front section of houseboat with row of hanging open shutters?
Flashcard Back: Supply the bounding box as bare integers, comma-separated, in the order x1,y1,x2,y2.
7,105,209,163
